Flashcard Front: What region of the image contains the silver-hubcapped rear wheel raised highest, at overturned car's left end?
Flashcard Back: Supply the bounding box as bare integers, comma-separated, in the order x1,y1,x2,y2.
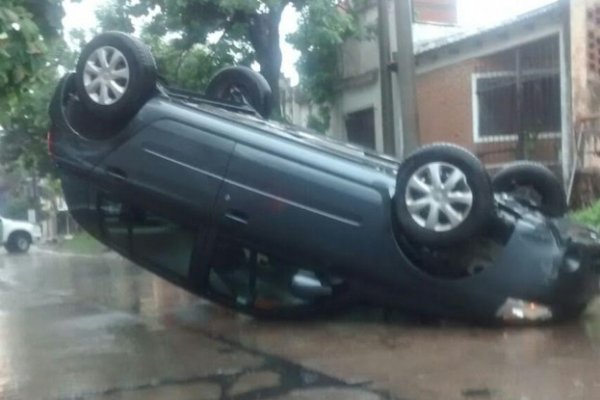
75,32,157,121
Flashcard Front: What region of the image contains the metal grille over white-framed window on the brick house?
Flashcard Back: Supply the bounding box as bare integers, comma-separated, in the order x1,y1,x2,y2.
472,35,563,172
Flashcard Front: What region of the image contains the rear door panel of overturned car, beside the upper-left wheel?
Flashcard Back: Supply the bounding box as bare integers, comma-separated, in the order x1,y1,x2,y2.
97,119,234,223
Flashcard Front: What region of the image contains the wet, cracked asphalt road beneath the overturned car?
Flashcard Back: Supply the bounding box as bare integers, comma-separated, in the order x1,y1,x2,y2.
0,250,600,400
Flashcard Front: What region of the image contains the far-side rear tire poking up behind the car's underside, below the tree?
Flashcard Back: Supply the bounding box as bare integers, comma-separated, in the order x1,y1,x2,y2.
205,66,273,119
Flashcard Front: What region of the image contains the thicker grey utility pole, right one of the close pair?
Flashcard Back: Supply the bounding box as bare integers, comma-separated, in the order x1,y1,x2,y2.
392,0,419,156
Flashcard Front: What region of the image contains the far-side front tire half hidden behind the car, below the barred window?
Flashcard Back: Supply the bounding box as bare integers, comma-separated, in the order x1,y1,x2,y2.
492,161,568,217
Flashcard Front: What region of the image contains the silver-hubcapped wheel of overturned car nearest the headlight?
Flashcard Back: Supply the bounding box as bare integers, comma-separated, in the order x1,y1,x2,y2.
394,143,494,247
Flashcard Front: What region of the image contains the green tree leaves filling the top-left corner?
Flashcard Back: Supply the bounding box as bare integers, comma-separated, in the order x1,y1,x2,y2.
0,0,64,112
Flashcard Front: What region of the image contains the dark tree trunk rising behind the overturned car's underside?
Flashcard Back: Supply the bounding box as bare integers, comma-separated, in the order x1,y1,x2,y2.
249,5,287,118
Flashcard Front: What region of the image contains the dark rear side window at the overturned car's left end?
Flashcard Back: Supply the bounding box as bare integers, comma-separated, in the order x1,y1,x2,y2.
99,195,196,277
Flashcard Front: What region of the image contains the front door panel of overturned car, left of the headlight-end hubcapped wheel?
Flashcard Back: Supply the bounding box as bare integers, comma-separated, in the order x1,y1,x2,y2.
215,139,390,265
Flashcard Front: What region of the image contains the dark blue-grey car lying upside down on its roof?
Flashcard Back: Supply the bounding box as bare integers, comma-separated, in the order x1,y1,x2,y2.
48,32,600,322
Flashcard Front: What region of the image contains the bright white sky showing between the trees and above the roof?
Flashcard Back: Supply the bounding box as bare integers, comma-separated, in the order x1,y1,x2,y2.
63,0,556,84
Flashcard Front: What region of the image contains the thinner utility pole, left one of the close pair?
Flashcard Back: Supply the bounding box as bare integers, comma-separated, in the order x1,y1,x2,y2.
377,0,396,155
